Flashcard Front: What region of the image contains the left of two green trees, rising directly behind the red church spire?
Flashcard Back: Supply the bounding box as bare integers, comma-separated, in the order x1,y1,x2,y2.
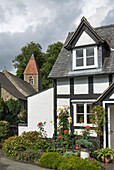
12,42,44,79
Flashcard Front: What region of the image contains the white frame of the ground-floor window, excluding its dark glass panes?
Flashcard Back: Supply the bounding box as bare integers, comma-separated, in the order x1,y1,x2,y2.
73,102,93,127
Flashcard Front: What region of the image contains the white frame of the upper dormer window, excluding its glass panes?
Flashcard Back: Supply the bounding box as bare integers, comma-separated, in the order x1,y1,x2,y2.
73,46,98,70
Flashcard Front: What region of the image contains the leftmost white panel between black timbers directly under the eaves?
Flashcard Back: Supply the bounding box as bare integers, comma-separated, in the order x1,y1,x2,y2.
57,78,70,94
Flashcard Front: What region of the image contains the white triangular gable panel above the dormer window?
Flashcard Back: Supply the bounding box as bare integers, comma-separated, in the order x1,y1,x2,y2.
75,31,96,47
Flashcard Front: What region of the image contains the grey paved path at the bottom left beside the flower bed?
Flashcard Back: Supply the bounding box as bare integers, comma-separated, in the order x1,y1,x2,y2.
0,150,46,170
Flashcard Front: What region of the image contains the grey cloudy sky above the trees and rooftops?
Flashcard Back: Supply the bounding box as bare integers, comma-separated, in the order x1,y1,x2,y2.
0,0,114,73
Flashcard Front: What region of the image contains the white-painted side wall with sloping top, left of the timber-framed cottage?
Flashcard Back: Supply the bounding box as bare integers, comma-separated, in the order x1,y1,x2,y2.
19,88,54,137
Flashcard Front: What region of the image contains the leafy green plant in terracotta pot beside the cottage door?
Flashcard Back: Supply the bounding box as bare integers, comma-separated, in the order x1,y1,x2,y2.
94,148,114,163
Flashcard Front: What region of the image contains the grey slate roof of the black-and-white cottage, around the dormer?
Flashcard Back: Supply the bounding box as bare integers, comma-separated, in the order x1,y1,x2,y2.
48,21,114,79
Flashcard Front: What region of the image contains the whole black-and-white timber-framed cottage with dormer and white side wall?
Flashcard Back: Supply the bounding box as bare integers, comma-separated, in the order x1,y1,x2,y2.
19,17,114,149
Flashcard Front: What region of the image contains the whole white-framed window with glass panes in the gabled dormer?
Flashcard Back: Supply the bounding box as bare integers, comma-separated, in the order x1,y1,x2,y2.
73,46,98,70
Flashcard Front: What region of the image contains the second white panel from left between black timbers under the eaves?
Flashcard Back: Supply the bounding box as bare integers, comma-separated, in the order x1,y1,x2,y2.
74,77,88,94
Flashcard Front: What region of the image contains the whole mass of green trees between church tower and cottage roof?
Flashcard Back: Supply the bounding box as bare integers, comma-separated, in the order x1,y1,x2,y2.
13,42,63,89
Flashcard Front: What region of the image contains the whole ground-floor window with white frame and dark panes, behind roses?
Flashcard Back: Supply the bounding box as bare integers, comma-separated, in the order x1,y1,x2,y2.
74,103,91,125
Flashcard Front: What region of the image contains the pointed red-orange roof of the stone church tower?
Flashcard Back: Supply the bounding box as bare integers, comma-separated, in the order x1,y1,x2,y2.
24,54,40,74
